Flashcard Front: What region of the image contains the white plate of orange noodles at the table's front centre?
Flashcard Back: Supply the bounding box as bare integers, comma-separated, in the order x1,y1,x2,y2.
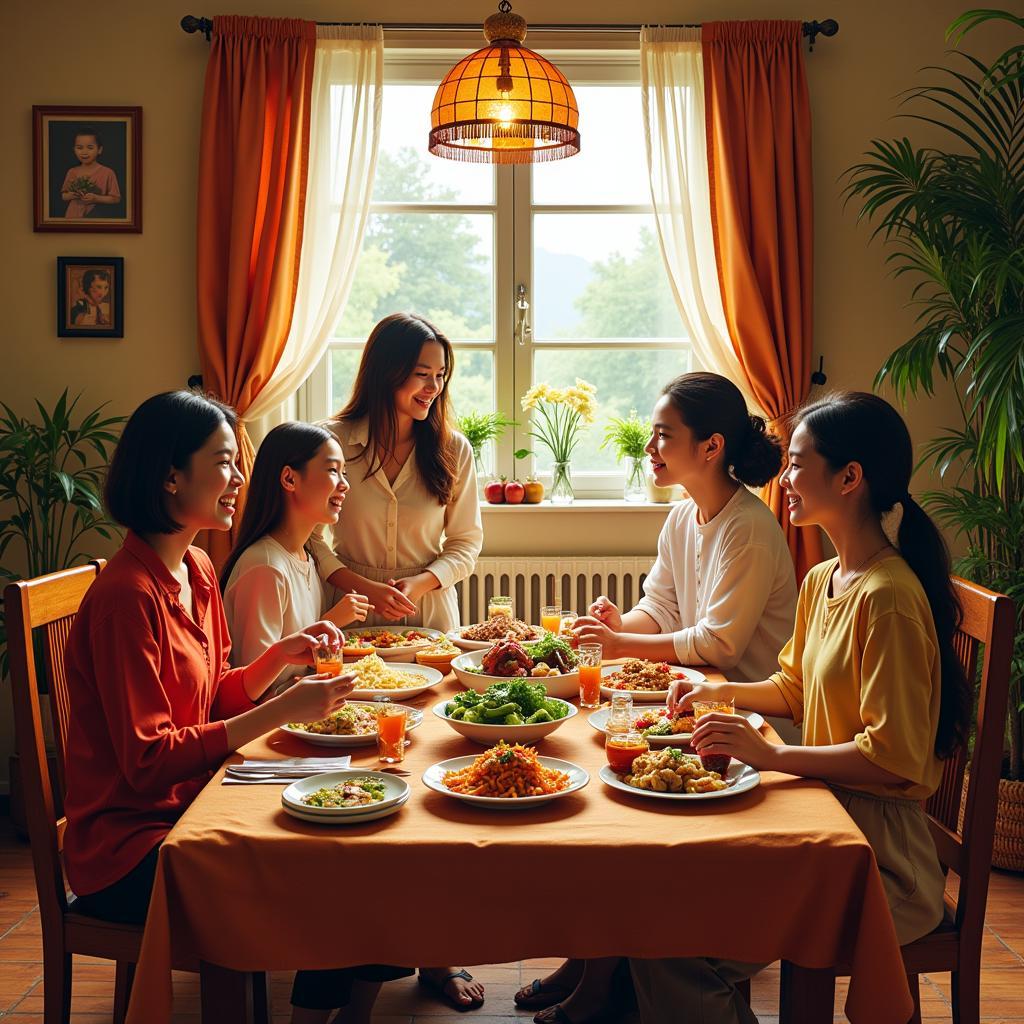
423,741,590,807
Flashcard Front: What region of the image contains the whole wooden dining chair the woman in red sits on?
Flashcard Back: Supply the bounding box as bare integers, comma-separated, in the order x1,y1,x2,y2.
4,560,269,1024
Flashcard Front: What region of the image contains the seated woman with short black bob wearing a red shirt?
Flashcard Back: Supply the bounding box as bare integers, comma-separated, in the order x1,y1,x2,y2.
65,391,352,924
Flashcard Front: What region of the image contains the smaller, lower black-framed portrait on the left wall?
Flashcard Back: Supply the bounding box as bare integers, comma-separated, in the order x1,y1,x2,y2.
57,256,125,338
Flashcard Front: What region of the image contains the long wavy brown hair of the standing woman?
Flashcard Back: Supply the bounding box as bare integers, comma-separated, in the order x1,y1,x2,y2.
335,313,459,505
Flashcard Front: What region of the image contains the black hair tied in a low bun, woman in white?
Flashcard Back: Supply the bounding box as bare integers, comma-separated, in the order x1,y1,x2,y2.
662,374,782,487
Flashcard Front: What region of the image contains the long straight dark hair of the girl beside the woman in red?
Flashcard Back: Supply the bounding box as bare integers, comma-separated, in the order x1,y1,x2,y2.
220,423,334,591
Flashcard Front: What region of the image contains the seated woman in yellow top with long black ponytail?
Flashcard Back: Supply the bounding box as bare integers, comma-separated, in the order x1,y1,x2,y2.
631,392,970,1022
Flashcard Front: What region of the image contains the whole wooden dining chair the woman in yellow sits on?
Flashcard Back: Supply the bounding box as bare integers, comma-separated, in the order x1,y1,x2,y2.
779,577,1016,1024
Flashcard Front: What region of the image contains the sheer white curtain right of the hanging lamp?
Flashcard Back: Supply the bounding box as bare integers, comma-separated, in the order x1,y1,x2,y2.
640,28,763,415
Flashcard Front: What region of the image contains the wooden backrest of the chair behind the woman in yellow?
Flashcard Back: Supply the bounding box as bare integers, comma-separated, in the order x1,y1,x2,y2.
926,577,1016,942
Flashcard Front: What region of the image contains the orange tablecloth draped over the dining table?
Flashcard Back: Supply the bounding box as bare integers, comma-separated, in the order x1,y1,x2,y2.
128,680,912,1024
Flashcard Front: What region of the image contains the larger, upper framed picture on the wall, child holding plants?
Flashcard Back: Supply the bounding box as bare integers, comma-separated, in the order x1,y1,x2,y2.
32,106,142,232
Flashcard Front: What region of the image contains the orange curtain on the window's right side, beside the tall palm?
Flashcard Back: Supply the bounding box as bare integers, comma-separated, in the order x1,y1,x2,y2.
701,22,822,581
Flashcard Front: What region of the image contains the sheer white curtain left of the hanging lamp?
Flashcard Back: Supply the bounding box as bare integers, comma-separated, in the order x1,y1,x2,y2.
246,25,384,436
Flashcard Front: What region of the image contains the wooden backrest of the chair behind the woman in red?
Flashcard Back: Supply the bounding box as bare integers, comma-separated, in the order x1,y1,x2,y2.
4,560,105,932
